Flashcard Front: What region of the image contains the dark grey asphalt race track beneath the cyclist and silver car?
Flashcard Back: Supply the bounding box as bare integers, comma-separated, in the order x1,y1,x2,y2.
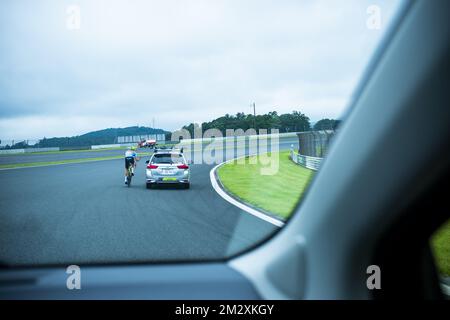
0,138,296,265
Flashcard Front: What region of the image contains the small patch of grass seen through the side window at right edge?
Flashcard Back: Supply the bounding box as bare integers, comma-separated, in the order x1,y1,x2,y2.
431,219,450,277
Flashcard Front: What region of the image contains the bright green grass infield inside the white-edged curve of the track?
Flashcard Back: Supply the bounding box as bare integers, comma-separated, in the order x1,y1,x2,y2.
217,151,314,219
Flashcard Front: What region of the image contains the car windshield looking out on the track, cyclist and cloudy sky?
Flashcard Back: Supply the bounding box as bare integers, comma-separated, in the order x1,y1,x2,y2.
0,0,402,267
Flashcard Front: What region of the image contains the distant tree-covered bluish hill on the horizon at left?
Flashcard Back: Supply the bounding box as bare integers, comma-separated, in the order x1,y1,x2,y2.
13,126,170,148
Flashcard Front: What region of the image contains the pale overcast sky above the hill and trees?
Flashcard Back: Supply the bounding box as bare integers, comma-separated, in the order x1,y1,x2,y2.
0,0,399,139
